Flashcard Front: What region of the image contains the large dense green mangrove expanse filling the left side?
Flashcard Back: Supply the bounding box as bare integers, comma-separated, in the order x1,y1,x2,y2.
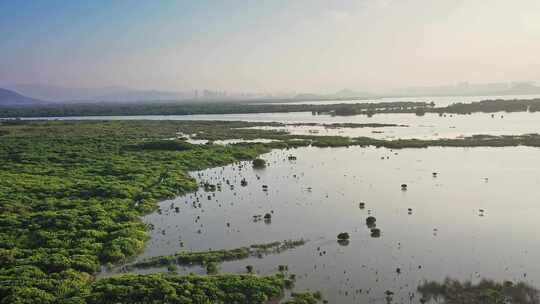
0,122,278,303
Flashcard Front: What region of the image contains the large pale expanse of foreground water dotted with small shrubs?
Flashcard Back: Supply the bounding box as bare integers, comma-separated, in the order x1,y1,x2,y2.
106,147,540,303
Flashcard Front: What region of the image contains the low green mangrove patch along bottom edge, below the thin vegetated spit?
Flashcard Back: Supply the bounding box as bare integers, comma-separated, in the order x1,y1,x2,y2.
86,274,285,304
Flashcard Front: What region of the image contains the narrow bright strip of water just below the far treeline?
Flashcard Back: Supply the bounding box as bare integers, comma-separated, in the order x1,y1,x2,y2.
23,112,540,139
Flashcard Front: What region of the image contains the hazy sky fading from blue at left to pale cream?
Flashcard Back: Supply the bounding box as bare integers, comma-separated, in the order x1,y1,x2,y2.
0,0,540,92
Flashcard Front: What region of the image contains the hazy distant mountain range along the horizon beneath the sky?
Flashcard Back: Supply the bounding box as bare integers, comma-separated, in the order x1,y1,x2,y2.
0,82,540,105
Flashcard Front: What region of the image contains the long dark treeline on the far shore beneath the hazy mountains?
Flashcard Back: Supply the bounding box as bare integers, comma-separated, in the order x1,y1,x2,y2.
0,99,540,118
